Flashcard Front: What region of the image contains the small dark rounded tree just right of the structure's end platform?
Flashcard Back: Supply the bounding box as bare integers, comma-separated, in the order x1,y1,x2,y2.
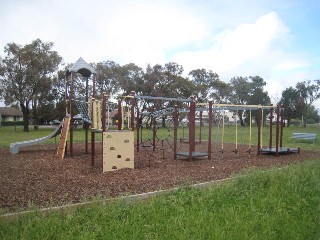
280,87,299,127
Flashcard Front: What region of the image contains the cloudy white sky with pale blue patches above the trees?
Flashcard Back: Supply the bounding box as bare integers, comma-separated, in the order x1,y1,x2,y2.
0,0,320,108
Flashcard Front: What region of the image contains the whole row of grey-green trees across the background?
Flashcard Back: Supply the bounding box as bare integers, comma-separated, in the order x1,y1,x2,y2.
0,39,320,131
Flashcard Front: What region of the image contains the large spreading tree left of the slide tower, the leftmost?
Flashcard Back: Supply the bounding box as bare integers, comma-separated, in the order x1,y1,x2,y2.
1,39,62,131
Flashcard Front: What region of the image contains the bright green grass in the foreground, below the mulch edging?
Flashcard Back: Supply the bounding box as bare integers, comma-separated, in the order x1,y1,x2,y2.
0,160,320,239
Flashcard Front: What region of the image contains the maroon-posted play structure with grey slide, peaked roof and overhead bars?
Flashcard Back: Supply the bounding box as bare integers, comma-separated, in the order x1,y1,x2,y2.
10,58,300,172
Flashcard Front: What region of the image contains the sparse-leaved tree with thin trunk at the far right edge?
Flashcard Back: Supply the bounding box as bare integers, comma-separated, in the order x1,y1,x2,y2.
296,80,320,127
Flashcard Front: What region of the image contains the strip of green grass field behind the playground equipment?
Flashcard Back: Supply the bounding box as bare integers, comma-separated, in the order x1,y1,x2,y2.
0,125,320,150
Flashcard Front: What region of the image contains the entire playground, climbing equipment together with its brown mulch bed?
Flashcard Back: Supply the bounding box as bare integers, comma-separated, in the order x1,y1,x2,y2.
0,58,319,211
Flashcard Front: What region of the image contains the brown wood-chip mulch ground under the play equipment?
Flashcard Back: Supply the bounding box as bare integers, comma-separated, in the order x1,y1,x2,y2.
0,143,319,211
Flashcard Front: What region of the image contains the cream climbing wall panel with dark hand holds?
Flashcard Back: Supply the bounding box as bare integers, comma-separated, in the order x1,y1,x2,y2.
103,131,134,172
